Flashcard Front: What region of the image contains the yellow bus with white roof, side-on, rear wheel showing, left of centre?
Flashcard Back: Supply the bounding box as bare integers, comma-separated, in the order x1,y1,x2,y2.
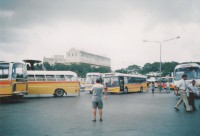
27,71,80,97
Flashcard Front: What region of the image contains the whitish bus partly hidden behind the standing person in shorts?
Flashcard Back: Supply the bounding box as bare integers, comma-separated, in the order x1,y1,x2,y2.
85,72,103,93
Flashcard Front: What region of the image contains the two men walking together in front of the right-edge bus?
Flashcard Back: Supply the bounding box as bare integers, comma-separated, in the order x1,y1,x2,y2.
174,74,200,111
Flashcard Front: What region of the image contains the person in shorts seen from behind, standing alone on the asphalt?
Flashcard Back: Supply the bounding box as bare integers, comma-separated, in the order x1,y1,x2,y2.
92,79,104,122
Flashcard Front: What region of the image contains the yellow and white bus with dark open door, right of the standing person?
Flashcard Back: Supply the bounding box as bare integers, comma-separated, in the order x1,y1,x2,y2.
103,73,147,93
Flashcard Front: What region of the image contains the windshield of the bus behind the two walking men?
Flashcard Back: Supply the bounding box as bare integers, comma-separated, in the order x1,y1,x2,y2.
174,67,200,80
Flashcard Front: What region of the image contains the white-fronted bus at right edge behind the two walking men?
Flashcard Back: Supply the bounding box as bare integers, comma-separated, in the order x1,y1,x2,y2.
174,63,200,94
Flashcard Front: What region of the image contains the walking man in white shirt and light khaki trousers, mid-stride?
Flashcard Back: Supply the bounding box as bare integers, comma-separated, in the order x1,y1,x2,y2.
174,74,190,111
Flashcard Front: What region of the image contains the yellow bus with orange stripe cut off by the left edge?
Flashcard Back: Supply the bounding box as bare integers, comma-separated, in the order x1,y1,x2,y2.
0,61,28,98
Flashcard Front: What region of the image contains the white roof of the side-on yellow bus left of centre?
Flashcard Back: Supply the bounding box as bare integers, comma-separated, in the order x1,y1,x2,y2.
27,71,77,76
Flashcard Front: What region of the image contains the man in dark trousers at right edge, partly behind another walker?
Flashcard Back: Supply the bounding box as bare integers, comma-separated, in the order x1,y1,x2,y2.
188,80,198,111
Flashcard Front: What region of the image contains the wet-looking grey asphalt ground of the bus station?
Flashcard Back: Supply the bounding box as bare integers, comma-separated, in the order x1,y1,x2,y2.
0,88,200,136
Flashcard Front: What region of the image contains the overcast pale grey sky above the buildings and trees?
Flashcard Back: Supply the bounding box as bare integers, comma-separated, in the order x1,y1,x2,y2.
0,0,200,70
